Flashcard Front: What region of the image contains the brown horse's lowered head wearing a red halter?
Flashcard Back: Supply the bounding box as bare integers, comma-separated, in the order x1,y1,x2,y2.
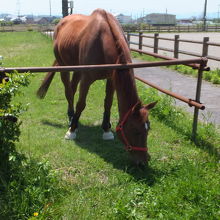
116,102,157,165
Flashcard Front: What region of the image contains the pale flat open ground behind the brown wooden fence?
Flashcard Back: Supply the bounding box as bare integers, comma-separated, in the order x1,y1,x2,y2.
131,32,220,69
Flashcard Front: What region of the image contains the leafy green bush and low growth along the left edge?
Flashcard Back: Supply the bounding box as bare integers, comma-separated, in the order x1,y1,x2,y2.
0,73,61,219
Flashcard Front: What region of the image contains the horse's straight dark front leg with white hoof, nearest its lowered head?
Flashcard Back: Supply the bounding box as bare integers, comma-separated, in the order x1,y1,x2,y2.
102,79,114,140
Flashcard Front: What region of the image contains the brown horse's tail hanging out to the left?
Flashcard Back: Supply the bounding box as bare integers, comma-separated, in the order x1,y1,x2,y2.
37,60,58,99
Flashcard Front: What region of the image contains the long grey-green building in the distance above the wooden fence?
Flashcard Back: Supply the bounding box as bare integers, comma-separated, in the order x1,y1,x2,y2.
143,13,176,26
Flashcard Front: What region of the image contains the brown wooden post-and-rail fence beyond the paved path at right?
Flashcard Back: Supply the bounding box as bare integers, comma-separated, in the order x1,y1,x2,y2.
127,32,220,61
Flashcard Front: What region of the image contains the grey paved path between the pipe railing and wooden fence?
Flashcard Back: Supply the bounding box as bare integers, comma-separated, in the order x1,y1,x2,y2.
133,59,220,125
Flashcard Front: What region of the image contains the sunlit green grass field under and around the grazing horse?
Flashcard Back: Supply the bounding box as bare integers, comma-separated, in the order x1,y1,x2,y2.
0,32,220,220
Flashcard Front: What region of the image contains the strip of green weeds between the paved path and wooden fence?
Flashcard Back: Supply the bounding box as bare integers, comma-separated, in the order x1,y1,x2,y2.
132,52,220,84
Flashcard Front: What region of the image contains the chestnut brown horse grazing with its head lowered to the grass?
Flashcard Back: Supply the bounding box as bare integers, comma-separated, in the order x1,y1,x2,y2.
37,9,156,164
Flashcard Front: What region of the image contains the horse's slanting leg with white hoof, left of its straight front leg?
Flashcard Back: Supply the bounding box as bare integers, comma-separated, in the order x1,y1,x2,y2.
65,79,92,140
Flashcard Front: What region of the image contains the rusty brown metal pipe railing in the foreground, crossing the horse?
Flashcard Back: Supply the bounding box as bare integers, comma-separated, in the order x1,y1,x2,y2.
0,54,208,140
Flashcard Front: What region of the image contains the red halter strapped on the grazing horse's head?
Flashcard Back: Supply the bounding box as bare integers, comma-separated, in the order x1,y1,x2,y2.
116,102,148,152
